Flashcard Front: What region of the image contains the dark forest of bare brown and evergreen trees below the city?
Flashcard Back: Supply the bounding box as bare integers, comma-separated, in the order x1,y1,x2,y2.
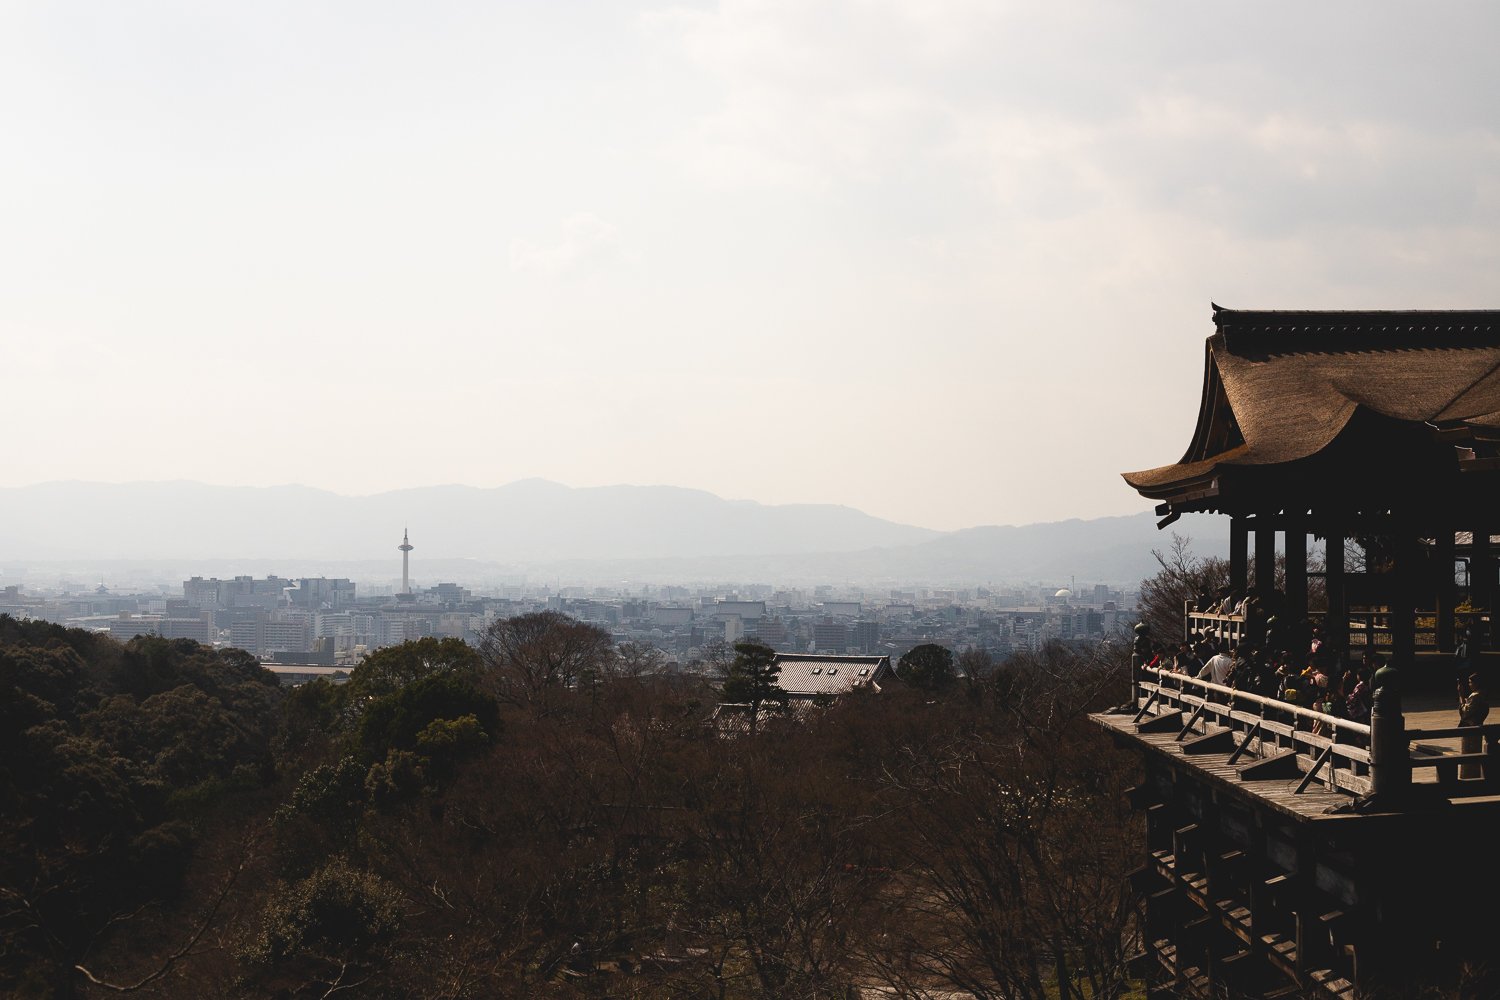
0,612,1140,1000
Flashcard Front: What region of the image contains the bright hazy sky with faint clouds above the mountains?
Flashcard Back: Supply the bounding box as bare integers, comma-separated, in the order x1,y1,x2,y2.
0,0,1500,528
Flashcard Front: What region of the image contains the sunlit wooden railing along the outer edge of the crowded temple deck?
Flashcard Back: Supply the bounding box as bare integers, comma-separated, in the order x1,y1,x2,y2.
1136,667,1500,798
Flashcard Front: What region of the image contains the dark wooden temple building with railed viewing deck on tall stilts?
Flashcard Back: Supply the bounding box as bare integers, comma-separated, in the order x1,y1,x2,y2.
1095,306,1500,1000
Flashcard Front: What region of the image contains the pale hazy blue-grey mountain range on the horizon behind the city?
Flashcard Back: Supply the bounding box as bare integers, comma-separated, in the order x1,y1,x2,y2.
0,480,1227,583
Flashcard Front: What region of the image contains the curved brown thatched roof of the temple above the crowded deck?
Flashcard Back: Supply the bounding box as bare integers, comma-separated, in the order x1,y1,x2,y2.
1125,306,1500,499
